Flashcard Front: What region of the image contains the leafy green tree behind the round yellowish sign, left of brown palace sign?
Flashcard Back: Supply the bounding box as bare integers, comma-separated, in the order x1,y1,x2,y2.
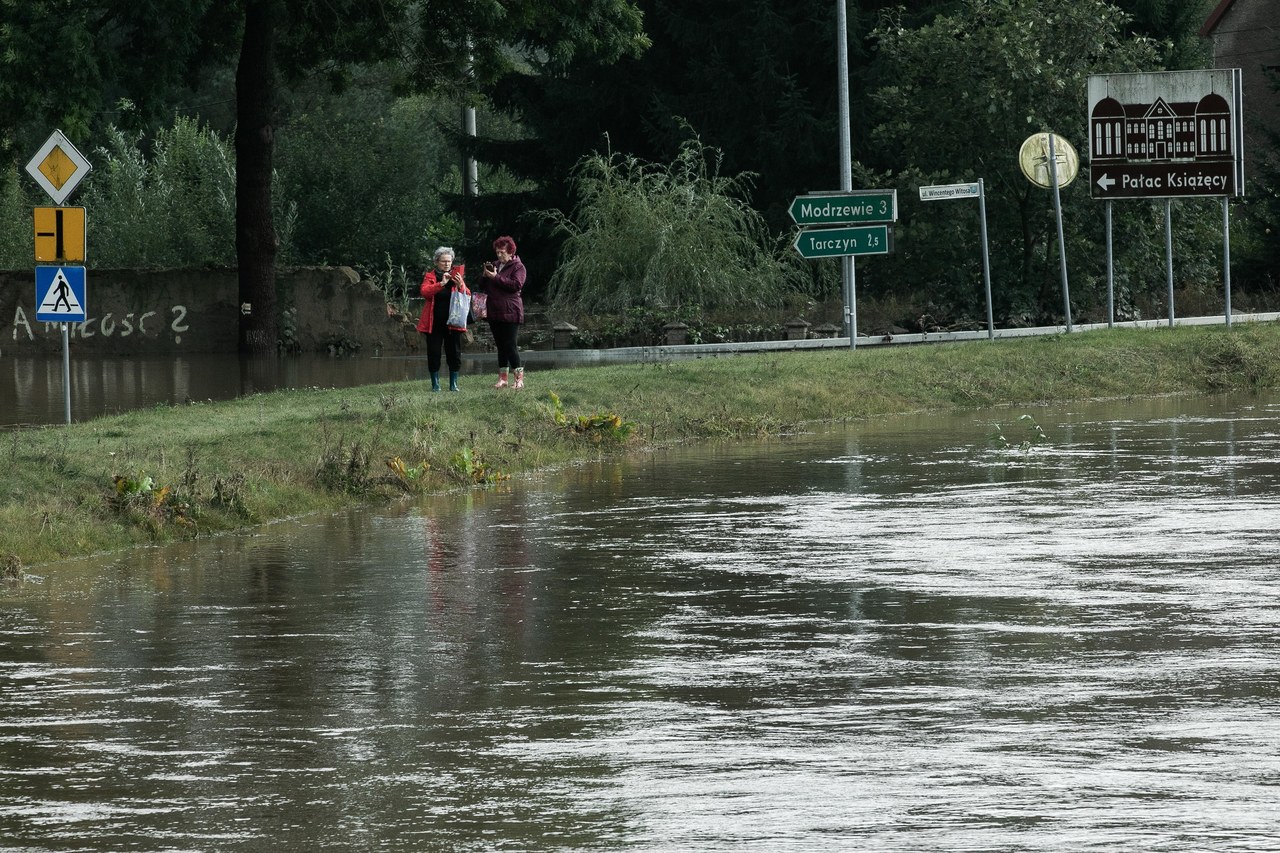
865,0,1158,323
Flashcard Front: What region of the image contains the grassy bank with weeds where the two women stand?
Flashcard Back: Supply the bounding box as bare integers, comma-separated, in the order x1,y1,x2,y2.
0,324,1280,574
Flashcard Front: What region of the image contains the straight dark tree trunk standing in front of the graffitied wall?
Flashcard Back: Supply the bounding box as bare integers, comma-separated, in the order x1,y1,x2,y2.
236,0,283,355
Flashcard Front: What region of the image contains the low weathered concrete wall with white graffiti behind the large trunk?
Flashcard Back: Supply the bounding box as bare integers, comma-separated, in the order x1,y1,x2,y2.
0,266,420,355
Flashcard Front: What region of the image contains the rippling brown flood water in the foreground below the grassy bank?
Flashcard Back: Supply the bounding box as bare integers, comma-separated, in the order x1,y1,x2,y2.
0,398,1280,853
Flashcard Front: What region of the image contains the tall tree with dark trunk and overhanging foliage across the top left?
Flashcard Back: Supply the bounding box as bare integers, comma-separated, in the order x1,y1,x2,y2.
0,0,645,353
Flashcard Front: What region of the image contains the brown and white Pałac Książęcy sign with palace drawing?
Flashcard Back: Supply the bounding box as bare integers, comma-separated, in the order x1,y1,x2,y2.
1089,68,1244,200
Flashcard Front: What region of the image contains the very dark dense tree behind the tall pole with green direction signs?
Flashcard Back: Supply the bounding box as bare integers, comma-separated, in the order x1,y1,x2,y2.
475,0,954,295
